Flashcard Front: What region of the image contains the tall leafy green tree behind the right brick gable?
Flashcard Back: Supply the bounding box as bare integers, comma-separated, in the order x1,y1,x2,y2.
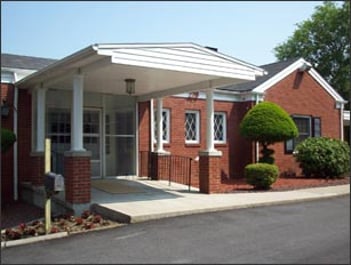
274,1,350,108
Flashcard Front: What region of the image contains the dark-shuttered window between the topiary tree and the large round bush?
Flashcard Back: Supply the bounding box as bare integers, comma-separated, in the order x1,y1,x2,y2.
285,115,322,153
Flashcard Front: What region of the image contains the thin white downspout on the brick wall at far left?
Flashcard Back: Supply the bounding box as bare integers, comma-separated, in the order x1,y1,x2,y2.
13,73,18,201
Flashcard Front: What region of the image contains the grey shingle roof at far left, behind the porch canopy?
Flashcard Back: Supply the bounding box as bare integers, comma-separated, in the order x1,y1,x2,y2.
1,53,57,70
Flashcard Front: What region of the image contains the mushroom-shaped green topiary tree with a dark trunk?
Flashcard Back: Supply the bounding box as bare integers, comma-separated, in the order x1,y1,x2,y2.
240,101,298,164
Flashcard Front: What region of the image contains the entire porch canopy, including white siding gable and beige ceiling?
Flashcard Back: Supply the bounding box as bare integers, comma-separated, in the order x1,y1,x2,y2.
16,43,264,100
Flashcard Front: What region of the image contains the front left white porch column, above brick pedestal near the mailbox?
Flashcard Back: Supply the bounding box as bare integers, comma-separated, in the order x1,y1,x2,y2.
71,74,85,151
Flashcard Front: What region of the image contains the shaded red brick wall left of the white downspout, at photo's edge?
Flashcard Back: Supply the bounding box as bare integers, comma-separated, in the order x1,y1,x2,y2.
0,84,14,204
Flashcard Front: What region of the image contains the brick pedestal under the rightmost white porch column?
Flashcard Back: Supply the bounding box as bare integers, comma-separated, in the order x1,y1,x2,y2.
199,151,222,194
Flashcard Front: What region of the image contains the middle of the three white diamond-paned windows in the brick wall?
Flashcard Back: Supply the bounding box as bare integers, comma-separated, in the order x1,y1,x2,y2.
185,110,200,143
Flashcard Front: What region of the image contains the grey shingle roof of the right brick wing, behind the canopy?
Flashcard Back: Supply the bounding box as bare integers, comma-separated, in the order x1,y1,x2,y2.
219,58,299,92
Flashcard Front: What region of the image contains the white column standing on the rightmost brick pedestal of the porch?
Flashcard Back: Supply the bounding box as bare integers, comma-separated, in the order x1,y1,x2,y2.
206,89,216,152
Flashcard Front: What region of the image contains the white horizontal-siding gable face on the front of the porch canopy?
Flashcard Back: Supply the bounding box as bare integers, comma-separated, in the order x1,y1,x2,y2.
93,43,264,80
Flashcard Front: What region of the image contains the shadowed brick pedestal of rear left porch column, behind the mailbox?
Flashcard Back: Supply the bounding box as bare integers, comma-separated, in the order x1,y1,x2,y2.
29,152,45,186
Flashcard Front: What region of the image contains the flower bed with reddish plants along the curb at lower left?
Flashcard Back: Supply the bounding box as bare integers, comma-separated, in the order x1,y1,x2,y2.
1,210,122,241
